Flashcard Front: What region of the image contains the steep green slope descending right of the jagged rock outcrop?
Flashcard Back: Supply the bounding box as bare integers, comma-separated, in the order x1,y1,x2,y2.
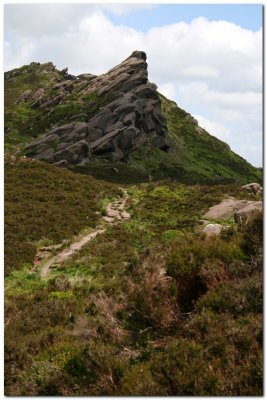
161,96,262,182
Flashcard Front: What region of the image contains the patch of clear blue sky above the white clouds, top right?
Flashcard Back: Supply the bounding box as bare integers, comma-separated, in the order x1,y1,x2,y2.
109,4,263,32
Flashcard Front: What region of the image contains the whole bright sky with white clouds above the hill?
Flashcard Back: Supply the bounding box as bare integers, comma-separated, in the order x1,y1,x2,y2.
4,2,263,167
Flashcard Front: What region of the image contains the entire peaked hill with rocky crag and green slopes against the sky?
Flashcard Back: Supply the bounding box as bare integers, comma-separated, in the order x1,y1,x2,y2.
5,51,261,184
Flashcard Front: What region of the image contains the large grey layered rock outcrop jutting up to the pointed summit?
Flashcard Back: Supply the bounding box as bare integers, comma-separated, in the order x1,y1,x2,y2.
25,51,171,166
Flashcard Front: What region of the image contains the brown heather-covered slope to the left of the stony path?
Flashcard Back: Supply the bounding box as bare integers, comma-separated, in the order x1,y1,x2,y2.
5,158,117,274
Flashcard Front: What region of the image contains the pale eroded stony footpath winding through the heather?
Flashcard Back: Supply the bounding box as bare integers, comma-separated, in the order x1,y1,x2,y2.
37,188,131,279
